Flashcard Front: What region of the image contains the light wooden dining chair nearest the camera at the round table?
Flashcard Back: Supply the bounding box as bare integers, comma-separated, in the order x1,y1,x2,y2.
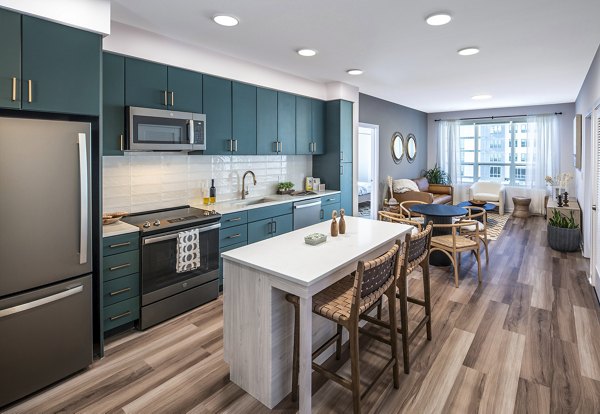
430,219,481,287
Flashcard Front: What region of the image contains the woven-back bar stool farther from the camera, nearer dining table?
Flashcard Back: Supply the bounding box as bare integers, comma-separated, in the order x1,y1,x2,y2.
370,222,433,374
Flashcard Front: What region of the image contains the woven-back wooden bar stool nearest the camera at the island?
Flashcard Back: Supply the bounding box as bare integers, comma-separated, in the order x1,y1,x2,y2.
286,241,410,413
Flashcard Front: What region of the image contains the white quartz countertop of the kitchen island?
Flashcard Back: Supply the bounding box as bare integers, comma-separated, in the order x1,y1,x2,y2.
221,217,412,286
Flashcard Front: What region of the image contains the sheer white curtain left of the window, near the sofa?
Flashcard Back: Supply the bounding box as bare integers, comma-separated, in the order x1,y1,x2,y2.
437,121,468,202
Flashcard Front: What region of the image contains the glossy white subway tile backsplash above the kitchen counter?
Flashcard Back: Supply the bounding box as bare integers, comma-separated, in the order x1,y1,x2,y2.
103,152,312,212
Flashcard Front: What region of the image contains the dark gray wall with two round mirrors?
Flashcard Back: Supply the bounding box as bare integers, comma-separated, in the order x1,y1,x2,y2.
357,93,427,204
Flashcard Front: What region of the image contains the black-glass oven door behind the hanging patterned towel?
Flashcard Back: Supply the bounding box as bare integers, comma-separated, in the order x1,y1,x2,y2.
141,223,221,306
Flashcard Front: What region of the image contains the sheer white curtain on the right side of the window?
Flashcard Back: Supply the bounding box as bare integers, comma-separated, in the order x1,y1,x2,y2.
525,115,560,214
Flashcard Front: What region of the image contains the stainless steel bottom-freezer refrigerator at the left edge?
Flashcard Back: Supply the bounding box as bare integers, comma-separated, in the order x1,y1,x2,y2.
0,117,92,407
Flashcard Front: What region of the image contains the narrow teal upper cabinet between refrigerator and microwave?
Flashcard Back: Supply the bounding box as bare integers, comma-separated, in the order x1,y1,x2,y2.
102,53,125,155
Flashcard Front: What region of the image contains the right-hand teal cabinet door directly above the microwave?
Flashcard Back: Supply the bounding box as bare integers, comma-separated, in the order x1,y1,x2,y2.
167,66,202,114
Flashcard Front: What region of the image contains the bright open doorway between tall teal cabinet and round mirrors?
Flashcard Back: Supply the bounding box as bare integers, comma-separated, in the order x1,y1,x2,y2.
357,123,379,220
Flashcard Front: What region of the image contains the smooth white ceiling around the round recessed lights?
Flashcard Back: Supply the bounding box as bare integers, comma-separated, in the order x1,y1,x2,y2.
111,0,600,113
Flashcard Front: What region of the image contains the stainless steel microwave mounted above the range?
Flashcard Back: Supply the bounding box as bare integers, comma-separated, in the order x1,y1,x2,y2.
127,106,206,151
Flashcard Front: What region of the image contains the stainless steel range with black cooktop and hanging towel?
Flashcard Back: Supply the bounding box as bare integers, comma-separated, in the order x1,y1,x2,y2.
123,206,221,329
